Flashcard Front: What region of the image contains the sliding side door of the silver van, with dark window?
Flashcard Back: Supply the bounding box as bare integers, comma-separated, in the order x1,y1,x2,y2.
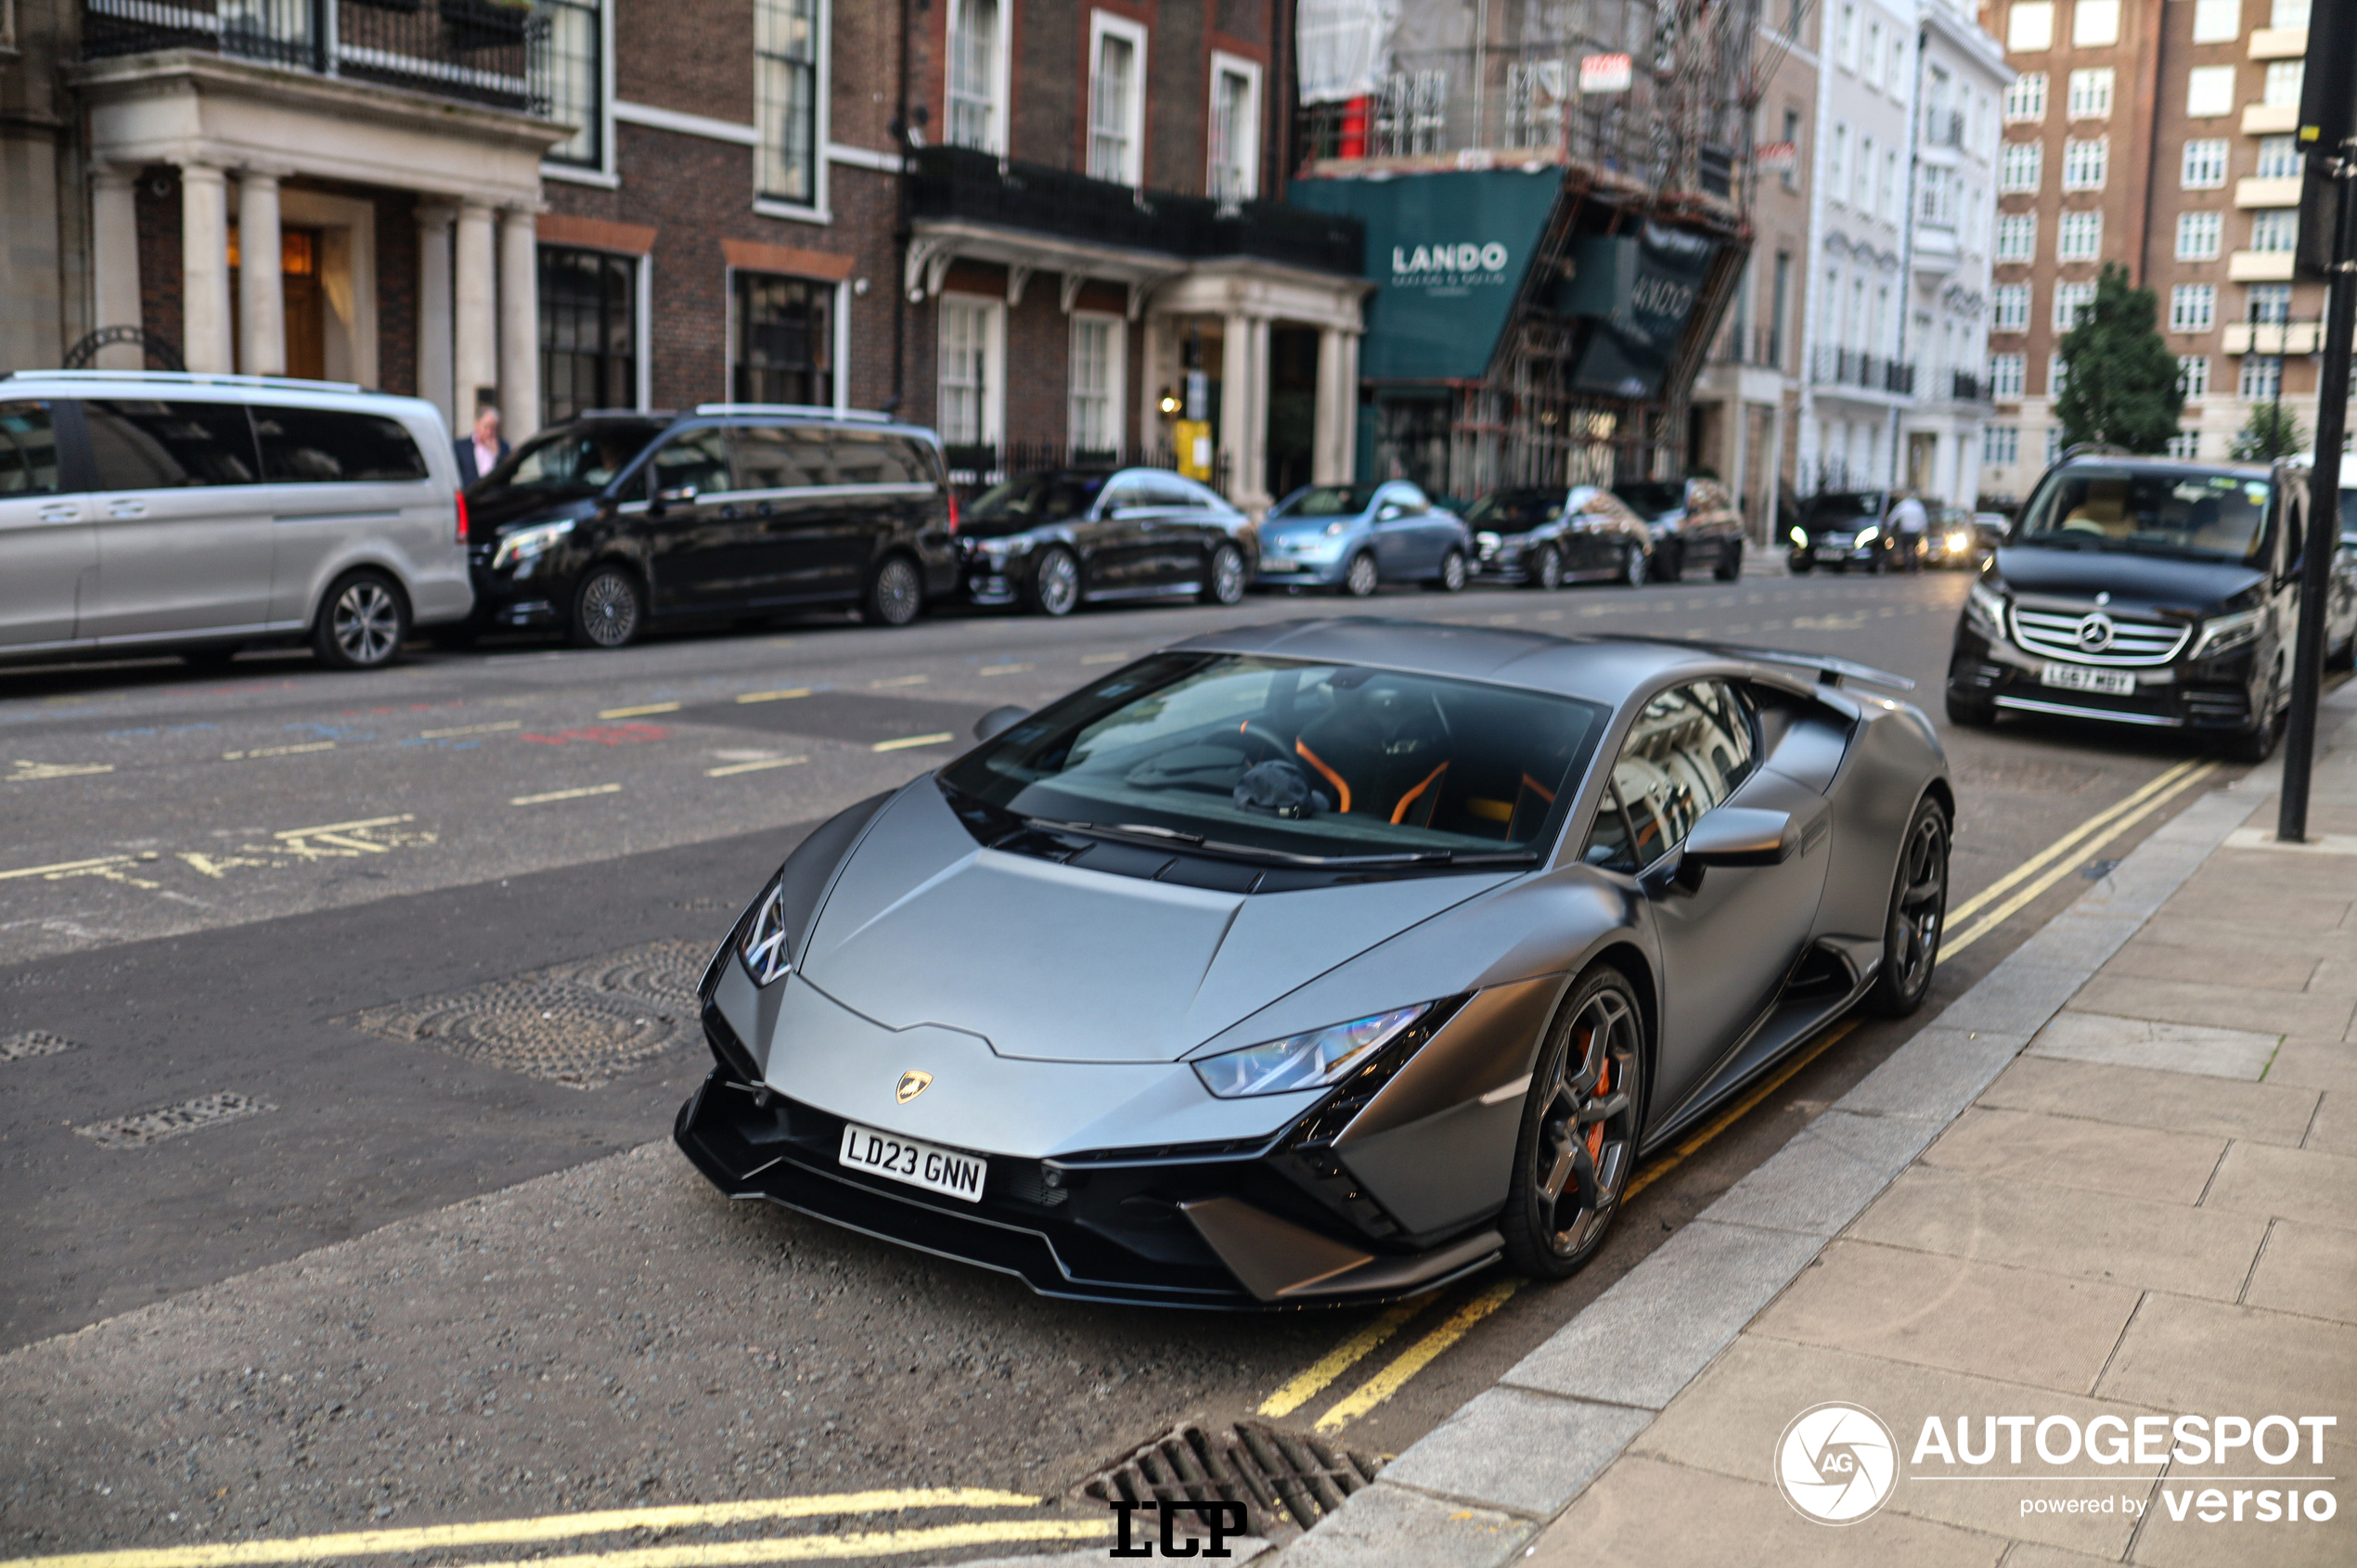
80,398,276,644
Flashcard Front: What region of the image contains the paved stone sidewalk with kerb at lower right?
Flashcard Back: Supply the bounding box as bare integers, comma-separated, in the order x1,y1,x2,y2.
1273,687,2357,1568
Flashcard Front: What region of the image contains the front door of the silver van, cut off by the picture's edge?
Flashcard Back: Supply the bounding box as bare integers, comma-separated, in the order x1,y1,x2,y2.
0,398,99,650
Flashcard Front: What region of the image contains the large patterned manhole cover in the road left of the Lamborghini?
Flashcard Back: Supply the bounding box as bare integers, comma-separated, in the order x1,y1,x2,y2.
337,941,710,1089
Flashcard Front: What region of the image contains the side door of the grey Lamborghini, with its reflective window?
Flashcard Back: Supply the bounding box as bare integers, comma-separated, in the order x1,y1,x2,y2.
1589,681,1829,1113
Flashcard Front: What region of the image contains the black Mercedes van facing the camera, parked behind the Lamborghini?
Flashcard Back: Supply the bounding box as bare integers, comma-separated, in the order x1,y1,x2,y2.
1947,455,2357,762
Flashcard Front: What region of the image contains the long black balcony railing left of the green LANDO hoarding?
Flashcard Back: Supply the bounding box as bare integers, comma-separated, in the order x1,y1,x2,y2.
909,147,1367,276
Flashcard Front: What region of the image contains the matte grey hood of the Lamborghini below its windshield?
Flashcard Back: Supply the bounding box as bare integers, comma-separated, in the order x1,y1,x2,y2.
799,780,1513,1063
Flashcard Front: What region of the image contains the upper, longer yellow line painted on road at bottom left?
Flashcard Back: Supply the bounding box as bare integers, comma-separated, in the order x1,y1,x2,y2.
0,1485,1055,1568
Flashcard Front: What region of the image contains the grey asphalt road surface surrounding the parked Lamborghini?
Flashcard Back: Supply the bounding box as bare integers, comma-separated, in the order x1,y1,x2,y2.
0,575,2232,1561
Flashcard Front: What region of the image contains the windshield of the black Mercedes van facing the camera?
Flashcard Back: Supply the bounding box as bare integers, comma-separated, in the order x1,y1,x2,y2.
2013,465,2274,561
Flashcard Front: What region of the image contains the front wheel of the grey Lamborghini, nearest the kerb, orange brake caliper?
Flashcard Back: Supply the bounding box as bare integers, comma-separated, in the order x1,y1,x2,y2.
1499,964,1645,1280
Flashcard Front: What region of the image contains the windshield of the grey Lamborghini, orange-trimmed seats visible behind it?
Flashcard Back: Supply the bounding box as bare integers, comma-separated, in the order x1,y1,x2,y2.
940,653,1605,863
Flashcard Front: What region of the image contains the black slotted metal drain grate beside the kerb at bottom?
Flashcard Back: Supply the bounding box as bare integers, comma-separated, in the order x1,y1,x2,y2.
1079,1421,1384,1540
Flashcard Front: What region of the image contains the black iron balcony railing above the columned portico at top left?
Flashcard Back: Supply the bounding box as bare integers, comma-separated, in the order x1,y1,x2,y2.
83,0,547,113
